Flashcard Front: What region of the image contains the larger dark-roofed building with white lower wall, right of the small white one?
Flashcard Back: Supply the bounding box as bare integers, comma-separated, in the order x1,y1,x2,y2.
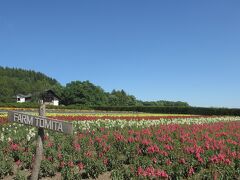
41,90,60,106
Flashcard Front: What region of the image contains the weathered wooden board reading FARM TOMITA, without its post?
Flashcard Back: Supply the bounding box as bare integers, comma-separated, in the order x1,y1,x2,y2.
8,111,73,134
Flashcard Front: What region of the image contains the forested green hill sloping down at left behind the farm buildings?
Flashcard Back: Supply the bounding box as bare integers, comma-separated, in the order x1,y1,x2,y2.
0,66,61,102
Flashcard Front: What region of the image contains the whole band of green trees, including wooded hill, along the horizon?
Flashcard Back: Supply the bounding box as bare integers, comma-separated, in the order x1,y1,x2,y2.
0,67,189,107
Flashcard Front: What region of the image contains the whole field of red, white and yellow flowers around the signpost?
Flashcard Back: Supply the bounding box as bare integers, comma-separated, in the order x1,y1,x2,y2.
0,113,240,179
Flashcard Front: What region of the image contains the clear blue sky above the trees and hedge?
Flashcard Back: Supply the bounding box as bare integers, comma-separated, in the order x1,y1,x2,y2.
0,0,240,108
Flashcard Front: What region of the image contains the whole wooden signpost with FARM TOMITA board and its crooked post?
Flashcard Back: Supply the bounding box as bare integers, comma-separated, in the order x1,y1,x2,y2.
8,102,73,180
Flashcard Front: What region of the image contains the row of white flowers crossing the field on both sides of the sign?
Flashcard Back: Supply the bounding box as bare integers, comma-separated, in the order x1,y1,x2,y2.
0,116,240,142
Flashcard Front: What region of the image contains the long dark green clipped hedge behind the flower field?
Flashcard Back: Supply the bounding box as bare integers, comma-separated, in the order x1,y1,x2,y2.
94,106,240,116
